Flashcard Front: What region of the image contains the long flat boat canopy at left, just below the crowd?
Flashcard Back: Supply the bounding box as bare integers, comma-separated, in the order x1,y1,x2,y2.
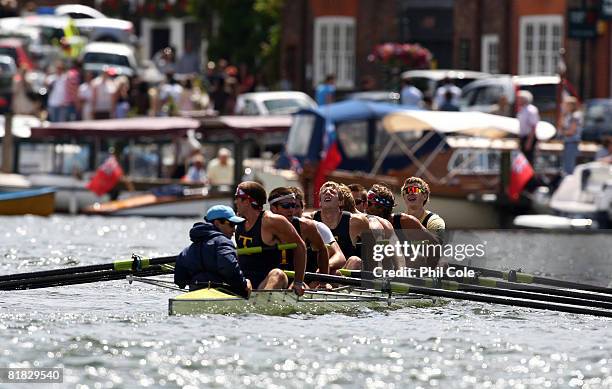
32,117,200,138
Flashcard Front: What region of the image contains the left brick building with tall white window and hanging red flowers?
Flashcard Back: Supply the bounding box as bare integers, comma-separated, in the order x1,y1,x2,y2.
280,0,453,93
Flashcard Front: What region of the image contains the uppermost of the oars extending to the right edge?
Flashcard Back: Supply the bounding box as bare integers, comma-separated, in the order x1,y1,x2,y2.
450,263,612,294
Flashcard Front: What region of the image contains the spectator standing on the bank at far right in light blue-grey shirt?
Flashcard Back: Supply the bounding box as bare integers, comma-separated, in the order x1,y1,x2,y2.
557,96,582,174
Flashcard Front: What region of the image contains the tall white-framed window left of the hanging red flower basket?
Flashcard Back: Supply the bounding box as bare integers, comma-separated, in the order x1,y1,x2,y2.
313,16,355,89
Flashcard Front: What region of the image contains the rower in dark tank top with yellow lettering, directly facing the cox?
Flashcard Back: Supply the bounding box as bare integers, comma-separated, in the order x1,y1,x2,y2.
234,181,306,295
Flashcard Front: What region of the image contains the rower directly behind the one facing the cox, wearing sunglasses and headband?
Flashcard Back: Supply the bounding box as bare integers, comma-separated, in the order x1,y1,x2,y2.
268,187,329,274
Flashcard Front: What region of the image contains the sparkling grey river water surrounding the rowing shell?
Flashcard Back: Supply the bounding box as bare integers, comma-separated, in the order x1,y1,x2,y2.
0,216,612,388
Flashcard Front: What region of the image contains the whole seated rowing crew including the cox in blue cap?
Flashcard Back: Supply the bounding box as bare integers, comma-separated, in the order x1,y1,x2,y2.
174,177,447,297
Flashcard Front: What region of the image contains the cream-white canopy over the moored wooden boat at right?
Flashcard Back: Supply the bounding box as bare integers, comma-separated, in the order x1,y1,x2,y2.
383,111,556,140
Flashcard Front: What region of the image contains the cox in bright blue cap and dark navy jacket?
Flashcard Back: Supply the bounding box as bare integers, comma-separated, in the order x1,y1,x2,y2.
174,205,253,298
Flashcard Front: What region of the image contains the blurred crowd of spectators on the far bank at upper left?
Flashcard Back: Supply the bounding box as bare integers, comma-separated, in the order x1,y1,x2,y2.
5,42,266,122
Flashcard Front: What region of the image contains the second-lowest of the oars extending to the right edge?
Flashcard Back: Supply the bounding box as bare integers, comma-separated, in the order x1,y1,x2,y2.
340,269,612,307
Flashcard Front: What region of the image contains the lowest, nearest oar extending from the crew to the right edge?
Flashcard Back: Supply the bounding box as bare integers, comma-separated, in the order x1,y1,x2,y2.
286,272,612,318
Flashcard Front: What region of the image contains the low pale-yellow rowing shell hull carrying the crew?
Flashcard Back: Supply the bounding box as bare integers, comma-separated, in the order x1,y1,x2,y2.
168,288,436,316
